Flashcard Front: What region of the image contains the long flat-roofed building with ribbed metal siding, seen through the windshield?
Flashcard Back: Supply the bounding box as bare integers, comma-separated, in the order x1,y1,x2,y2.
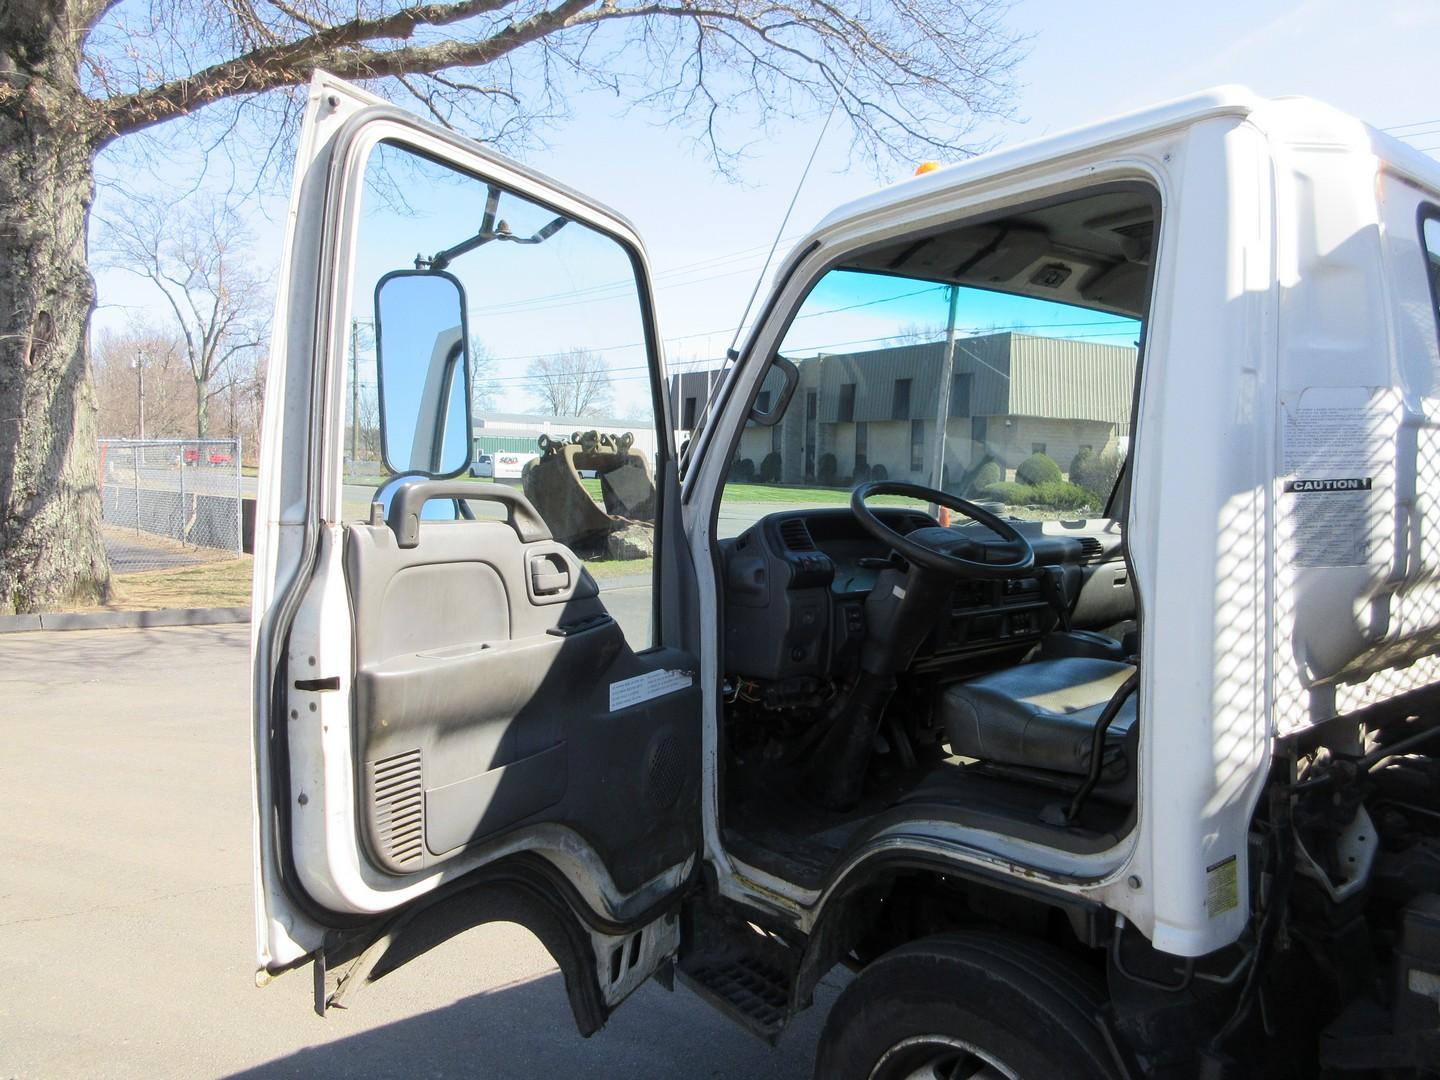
670,333,1136,484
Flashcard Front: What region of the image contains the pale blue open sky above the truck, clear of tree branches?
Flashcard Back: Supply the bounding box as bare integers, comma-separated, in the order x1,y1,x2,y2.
95,0,1440,411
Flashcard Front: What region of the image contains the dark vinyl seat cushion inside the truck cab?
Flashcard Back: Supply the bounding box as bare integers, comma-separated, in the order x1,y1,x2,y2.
940,657,1136,780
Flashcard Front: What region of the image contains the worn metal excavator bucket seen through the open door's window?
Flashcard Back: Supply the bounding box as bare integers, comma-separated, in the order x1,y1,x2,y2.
521,431,655,559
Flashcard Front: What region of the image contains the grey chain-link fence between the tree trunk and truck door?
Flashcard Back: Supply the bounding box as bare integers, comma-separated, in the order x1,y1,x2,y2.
99,439,242,573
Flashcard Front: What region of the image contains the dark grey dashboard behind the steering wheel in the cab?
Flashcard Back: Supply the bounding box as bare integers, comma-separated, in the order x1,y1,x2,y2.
721,507,1135,681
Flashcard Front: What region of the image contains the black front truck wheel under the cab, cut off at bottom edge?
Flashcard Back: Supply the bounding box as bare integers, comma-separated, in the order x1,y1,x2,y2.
815,932,1113,1080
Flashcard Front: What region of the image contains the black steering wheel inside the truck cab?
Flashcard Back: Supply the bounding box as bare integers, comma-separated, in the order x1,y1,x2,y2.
850,480,1035,577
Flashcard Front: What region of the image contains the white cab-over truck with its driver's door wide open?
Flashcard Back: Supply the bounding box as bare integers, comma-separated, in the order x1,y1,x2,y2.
253,75,1440,1080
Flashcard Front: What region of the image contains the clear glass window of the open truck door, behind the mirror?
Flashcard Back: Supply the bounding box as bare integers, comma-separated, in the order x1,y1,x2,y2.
344,143,661,649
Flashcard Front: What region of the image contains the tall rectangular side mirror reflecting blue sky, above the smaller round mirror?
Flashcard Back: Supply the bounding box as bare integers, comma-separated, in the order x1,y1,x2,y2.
374,271,471,478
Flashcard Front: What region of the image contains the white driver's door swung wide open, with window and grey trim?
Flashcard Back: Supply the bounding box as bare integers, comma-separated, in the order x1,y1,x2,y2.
252,73,701,1034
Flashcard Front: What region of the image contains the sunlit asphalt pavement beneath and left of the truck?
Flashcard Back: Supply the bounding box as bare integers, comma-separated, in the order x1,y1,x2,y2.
0,625,835,1080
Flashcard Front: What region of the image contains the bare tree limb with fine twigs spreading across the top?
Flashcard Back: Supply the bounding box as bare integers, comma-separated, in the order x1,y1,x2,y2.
86,0,1020,171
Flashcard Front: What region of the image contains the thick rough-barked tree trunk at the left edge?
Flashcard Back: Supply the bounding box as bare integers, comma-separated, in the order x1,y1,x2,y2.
0,0,109,612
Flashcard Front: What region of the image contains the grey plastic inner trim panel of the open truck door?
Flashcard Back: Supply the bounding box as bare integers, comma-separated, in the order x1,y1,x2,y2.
346,520,698,883
